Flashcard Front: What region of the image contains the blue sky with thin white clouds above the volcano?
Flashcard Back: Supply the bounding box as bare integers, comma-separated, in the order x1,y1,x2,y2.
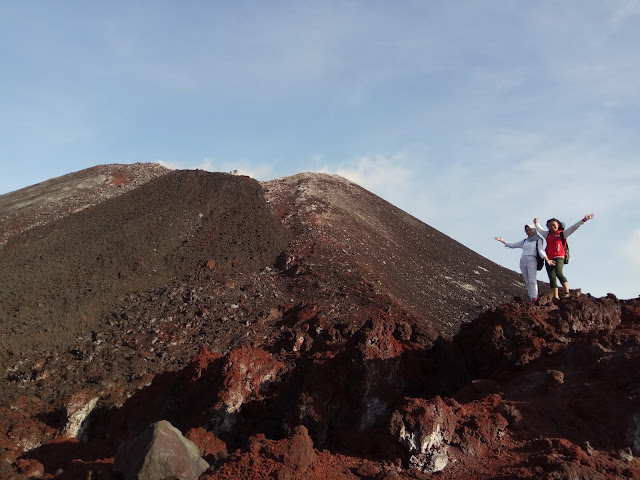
0,0,640,298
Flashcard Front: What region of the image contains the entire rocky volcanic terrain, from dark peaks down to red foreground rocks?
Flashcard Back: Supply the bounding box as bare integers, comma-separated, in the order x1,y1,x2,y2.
0,165,640,480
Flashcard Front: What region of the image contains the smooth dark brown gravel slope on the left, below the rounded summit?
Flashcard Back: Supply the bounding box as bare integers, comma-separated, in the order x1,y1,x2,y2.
0,171,286,364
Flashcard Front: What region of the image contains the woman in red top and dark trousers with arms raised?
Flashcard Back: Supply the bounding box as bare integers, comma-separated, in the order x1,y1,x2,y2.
533,213,595,299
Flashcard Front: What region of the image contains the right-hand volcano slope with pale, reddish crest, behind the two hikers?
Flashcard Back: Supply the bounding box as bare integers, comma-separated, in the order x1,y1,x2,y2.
264,174,524,335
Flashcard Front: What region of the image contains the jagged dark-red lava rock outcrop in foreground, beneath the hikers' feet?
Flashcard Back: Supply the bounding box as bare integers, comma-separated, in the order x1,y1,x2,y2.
3,297,640,480
